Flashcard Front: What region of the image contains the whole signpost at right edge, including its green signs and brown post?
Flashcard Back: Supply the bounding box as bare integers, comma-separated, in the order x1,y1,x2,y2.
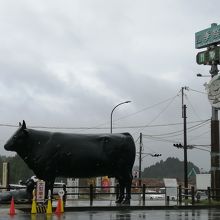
195,23,220,200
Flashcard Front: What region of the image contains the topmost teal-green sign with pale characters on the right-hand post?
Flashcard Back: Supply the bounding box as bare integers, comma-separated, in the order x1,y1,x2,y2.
195,23,220,49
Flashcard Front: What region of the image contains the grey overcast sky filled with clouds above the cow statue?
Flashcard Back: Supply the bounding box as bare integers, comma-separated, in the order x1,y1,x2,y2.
0,0,220,170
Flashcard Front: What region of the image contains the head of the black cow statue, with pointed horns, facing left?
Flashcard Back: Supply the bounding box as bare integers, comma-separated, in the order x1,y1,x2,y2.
4,121,28,152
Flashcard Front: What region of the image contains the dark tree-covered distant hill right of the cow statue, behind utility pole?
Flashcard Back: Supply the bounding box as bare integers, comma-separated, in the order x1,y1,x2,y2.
142,157,199,180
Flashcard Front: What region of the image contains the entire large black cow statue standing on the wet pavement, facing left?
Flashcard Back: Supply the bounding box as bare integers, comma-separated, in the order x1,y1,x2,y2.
4,121,136,204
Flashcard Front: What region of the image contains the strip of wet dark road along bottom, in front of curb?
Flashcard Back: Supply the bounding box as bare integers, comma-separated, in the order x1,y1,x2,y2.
0,209,220,220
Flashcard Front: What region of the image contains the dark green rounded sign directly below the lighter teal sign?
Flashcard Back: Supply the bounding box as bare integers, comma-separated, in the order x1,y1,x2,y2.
196,46,220,65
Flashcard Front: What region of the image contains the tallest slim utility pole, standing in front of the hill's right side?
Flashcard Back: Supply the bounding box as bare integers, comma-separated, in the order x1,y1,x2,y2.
182,87,188,195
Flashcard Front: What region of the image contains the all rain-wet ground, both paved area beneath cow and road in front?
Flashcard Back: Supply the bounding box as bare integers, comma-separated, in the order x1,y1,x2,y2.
0,199,220,220
